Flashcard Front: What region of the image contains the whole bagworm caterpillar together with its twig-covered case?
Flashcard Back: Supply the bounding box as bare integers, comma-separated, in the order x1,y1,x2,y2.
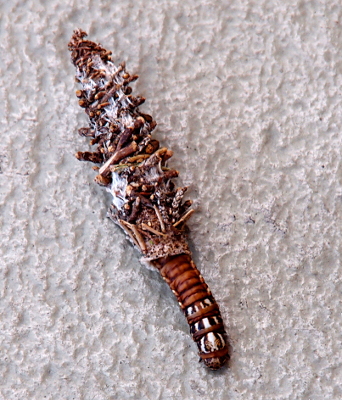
68,30,229,370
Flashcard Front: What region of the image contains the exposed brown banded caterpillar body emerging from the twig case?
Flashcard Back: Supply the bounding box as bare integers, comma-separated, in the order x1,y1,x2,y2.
153,254,229,370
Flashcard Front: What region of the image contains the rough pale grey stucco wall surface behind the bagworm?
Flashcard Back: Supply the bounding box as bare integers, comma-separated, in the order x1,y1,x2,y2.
0,0,342,400
